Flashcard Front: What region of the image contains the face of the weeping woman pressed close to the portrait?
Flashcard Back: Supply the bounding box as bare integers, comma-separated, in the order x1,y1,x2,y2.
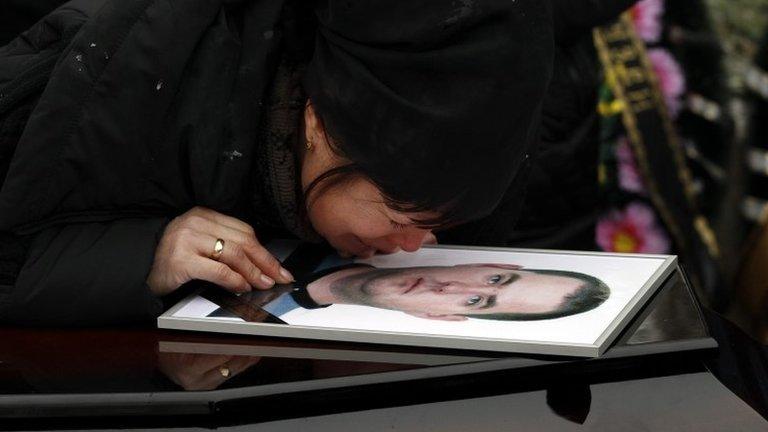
301,105,435,257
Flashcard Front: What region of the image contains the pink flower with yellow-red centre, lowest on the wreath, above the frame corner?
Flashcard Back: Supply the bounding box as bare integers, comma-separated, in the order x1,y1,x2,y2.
596,202,670,254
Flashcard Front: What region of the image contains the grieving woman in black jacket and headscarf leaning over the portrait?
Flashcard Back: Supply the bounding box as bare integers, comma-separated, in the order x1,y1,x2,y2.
0,0,636,325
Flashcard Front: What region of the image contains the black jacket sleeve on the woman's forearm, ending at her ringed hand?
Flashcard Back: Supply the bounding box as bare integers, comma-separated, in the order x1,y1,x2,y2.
0,218,169,326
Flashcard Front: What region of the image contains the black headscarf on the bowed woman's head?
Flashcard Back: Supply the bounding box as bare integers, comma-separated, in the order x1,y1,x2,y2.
304,0,553,223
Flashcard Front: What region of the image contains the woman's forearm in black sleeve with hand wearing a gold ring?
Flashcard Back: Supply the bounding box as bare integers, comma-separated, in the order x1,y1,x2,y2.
0,207,293,326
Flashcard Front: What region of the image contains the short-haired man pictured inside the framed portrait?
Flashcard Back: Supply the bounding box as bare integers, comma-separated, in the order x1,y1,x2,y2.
209,263,610,321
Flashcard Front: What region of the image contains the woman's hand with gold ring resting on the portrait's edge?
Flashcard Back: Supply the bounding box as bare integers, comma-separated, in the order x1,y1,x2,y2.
147,207,293,296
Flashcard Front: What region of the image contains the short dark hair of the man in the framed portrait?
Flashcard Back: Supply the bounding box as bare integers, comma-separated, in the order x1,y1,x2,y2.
466,269,611,321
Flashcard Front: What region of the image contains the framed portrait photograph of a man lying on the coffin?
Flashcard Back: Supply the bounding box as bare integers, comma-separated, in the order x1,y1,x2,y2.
158,241,677,357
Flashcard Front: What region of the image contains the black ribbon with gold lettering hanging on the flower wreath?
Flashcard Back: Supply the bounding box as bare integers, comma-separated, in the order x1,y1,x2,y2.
594,13,720,296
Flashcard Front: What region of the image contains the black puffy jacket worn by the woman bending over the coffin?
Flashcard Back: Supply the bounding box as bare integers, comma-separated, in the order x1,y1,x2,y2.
0,0,292,325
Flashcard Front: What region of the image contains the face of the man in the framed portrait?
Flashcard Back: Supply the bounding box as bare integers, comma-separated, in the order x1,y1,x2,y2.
331,264,584,321
